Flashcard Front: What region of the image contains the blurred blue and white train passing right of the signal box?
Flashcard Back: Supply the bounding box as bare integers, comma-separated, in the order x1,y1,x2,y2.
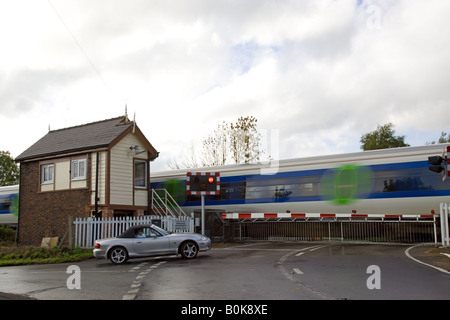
151,144,450,217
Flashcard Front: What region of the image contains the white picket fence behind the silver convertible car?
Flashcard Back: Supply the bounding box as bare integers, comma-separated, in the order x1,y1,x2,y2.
73,216,194,248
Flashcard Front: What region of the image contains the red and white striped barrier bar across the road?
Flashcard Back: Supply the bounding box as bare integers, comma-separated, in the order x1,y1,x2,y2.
222,212,434,219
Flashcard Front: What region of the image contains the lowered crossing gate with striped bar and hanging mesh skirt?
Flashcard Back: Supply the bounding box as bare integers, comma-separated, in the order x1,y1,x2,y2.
222,213,438,244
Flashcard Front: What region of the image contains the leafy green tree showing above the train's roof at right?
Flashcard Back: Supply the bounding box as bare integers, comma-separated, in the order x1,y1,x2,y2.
361,123,409,151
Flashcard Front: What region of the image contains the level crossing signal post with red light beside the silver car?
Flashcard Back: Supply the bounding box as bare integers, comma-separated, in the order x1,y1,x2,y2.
186,172,220,235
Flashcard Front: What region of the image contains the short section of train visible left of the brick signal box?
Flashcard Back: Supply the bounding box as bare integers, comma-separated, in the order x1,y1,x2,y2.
0,185,19,227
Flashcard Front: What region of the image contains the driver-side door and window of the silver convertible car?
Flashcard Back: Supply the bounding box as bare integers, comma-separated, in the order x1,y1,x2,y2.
133,227,169,255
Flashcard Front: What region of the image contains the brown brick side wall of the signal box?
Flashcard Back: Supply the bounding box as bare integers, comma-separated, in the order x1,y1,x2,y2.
19,161,90,245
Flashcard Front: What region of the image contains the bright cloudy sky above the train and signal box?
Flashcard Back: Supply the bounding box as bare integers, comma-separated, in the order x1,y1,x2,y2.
0,0,450,171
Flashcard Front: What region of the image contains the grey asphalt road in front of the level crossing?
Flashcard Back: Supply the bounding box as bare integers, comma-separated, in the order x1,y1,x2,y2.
0,242,450,301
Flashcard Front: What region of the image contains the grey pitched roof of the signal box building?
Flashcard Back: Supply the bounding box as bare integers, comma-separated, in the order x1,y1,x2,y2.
15,116,158,161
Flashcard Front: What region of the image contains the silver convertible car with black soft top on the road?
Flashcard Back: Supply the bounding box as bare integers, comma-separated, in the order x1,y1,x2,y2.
93,225,211,264
